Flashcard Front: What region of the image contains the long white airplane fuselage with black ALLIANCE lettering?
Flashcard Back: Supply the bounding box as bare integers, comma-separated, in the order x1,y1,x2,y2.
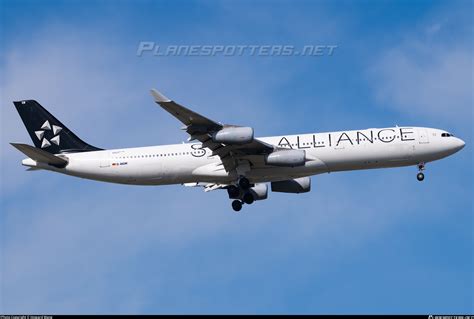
23,127,464,185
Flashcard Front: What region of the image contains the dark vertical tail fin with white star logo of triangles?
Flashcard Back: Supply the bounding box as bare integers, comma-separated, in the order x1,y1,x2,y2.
13,100,100,154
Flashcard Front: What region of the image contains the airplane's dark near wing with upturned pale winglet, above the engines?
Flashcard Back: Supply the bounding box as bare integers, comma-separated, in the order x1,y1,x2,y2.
151,89,275,159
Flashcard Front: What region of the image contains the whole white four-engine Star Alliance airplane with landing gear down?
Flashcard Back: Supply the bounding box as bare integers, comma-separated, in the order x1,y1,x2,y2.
11,89,465,212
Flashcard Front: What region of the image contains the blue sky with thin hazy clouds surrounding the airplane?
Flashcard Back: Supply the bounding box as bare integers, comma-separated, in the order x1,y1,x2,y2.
0,0,474,314
